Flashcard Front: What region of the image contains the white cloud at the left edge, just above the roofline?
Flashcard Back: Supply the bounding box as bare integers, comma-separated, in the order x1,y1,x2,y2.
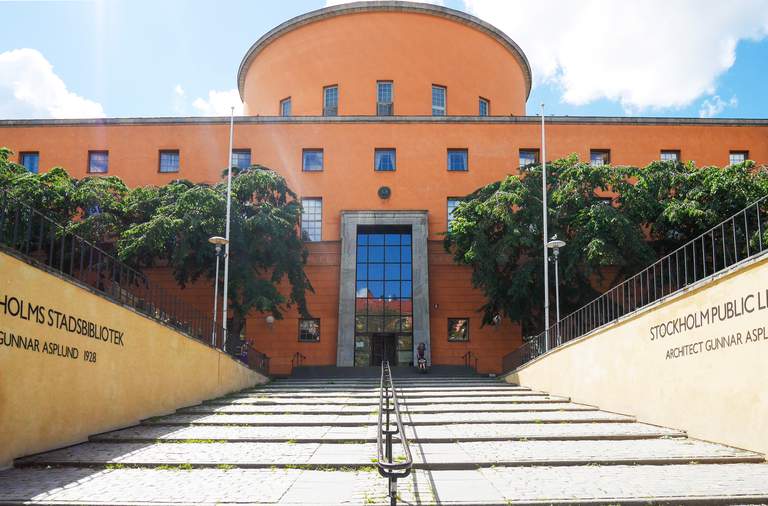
0,48,105,119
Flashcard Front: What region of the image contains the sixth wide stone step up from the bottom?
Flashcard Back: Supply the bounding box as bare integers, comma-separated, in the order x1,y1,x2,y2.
213,395,570,406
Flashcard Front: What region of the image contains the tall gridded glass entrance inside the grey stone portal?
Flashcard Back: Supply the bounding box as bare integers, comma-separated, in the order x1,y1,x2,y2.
355,226,413,367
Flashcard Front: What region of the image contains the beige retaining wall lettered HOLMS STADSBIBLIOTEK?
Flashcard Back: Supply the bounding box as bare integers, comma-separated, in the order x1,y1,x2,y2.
0,252,267,468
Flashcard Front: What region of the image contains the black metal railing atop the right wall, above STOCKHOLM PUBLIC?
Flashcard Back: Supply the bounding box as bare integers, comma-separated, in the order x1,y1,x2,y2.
502,195,768,372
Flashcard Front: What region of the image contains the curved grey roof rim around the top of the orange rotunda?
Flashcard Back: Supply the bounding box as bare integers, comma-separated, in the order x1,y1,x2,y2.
237,0,533,101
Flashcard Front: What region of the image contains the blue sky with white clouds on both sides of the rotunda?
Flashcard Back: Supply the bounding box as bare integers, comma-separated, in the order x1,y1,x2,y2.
0,0,768,118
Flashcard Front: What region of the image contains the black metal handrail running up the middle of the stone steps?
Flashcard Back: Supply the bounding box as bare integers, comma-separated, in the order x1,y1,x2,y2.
376,360,413,506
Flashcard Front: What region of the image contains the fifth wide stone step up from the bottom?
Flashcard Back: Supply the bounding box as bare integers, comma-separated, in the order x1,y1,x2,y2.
179,401,596,415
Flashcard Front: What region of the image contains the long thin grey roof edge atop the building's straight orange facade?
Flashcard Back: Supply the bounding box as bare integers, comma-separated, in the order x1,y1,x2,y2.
0,116,768,128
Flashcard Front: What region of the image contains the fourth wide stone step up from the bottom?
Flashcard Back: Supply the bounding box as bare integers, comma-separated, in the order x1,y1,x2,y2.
144,410,635,427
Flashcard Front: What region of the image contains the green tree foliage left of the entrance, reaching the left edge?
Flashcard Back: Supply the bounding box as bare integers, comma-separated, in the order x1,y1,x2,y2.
0,148,312,351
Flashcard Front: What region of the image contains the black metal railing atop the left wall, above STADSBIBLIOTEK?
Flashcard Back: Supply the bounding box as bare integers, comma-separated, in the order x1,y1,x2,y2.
0,189,272,372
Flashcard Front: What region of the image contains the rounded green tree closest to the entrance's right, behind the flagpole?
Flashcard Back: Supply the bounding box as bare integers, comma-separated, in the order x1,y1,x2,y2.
444,156,654,333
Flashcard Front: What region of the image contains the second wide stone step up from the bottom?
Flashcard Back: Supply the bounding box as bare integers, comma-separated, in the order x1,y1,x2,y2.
16,438,764,469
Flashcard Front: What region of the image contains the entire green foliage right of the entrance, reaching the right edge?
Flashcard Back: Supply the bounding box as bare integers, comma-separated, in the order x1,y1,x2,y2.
444,156,768,333
